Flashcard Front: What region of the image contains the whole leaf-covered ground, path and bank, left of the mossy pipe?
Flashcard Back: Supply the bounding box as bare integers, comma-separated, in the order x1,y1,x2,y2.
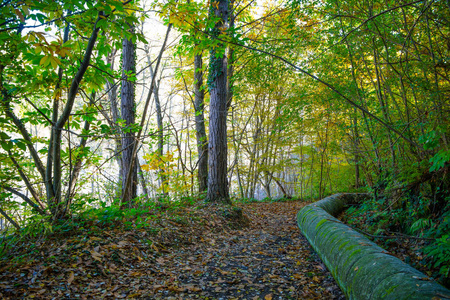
0,201,345,300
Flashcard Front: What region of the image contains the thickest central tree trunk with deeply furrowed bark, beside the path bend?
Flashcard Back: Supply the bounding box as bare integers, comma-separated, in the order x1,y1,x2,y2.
207,0,231,203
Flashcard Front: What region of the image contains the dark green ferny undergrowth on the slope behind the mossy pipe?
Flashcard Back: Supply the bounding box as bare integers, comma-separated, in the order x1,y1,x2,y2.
343,195,450,287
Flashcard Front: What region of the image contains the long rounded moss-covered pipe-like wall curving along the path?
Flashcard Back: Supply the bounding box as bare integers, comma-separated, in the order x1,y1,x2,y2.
297,194,450,300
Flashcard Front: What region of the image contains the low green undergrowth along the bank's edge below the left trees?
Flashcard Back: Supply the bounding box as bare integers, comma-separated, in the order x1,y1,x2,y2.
0,197,202,261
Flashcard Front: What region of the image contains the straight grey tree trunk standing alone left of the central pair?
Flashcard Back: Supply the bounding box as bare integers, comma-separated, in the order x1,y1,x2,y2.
120,27,137,205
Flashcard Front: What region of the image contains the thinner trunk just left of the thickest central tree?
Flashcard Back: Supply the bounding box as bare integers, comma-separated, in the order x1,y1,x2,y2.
194,54,208,193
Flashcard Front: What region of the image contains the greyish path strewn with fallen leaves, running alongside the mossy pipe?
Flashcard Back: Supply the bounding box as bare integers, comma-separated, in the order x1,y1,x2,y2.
151,202,345,300
